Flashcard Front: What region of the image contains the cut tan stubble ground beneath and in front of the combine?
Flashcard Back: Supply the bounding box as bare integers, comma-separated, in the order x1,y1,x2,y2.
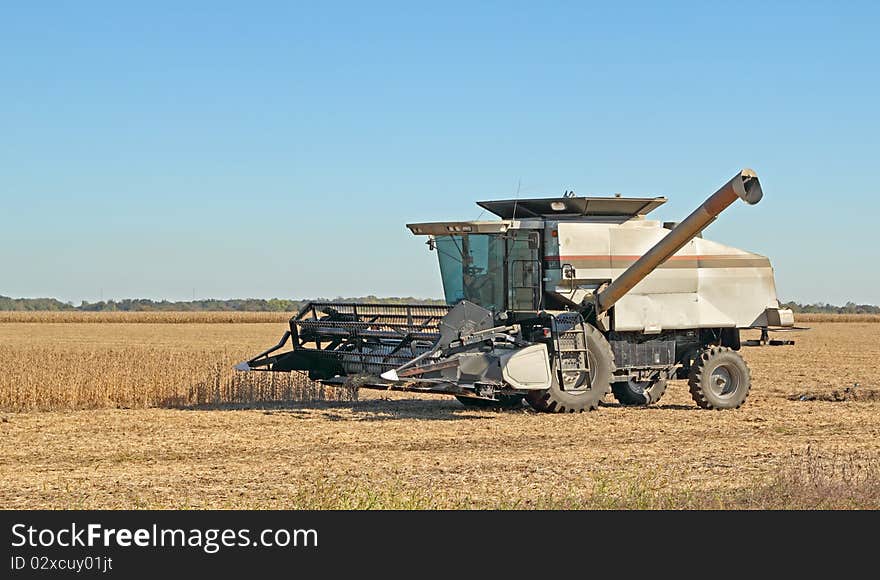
0,323,880,509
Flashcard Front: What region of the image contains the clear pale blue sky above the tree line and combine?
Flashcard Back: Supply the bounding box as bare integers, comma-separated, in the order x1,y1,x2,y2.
0,1,880,304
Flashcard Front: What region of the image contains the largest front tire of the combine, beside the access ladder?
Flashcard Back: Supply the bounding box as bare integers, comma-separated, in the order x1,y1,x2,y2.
526,323,614,413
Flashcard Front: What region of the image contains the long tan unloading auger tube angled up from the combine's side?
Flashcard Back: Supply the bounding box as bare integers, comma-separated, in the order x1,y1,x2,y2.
597,169,764,313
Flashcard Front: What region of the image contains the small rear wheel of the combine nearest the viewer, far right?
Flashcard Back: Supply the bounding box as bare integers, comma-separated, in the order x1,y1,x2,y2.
688,346,752,409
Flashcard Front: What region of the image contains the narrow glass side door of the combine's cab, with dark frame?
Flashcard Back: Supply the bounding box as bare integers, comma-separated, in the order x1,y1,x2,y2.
507,230,541,310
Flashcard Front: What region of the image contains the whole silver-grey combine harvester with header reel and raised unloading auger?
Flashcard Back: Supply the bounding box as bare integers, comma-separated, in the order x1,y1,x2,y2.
236,169,794,413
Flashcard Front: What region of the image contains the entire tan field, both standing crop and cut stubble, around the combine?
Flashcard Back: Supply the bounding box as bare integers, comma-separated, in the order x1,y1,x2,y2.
0,322,880,509
